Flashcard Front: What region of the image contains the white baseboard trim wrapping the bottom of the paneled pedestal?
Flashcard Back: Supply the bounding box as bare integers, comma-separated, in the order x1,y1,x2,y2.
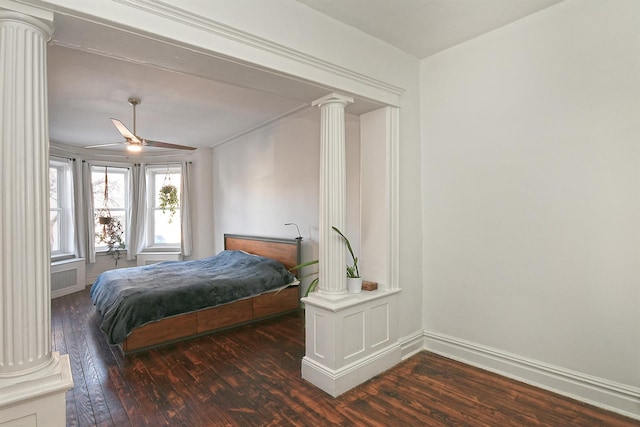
302,344,401,397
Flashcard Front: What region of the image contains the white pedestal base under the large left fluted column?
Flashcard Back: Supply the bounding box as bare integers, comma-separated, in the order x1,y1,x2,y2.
0,352,73,427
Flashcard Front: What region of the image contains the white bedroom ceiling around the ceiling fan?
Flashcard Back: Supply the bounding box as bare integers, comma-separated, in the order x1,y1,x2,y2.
48,45,305,150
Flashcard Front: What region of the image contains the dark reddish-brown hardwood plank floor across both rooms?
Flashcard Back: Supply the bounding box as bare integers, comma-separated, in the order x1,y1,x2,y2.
52,291,640,427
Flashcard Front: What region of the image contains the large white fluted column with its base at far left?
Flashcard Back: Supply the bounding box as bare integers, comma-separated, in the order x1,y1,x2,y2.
0,2,73,426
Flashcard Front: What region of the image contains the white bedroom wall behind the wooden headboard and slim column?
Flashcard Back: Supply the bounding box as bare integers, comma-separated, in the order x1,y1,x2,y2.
213,107,360,296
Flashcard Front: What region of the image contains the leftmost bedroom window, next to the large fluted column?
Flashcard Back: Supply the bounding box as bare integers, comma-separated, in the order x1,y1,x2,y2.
49,159,75,259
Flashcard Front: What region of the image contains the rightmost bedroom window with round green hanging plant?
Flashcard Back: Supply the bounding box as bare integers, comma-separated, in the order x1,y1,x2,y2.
146,164,181,249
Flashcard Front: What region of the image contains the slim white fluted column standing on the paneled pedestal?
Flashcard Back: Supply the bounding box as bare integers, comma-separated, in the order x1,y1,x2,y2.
312,93,353,298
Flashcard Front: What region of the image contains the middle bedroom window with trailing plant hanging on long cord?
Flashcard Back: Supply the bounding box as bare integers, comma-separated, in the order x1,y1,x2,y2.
91,166,129,252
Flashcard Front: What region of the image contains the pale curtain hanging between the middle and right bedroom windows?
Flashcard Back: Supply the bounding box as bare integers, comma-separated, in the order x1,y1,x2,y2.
127,164,147,260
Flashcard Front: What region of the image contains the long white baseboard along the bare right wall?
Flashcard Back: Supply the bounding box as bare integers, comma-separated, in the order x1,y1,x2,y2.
424,331,640,419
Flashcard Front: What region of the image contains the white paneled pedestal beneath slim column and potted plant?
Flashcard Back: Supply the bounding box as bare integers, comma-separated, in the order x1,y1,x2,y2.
302,289,402,397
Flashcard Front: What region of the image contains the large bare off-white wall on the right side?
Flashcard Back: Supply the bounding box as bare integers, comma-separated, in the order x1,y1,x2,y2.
421,0,640,414
